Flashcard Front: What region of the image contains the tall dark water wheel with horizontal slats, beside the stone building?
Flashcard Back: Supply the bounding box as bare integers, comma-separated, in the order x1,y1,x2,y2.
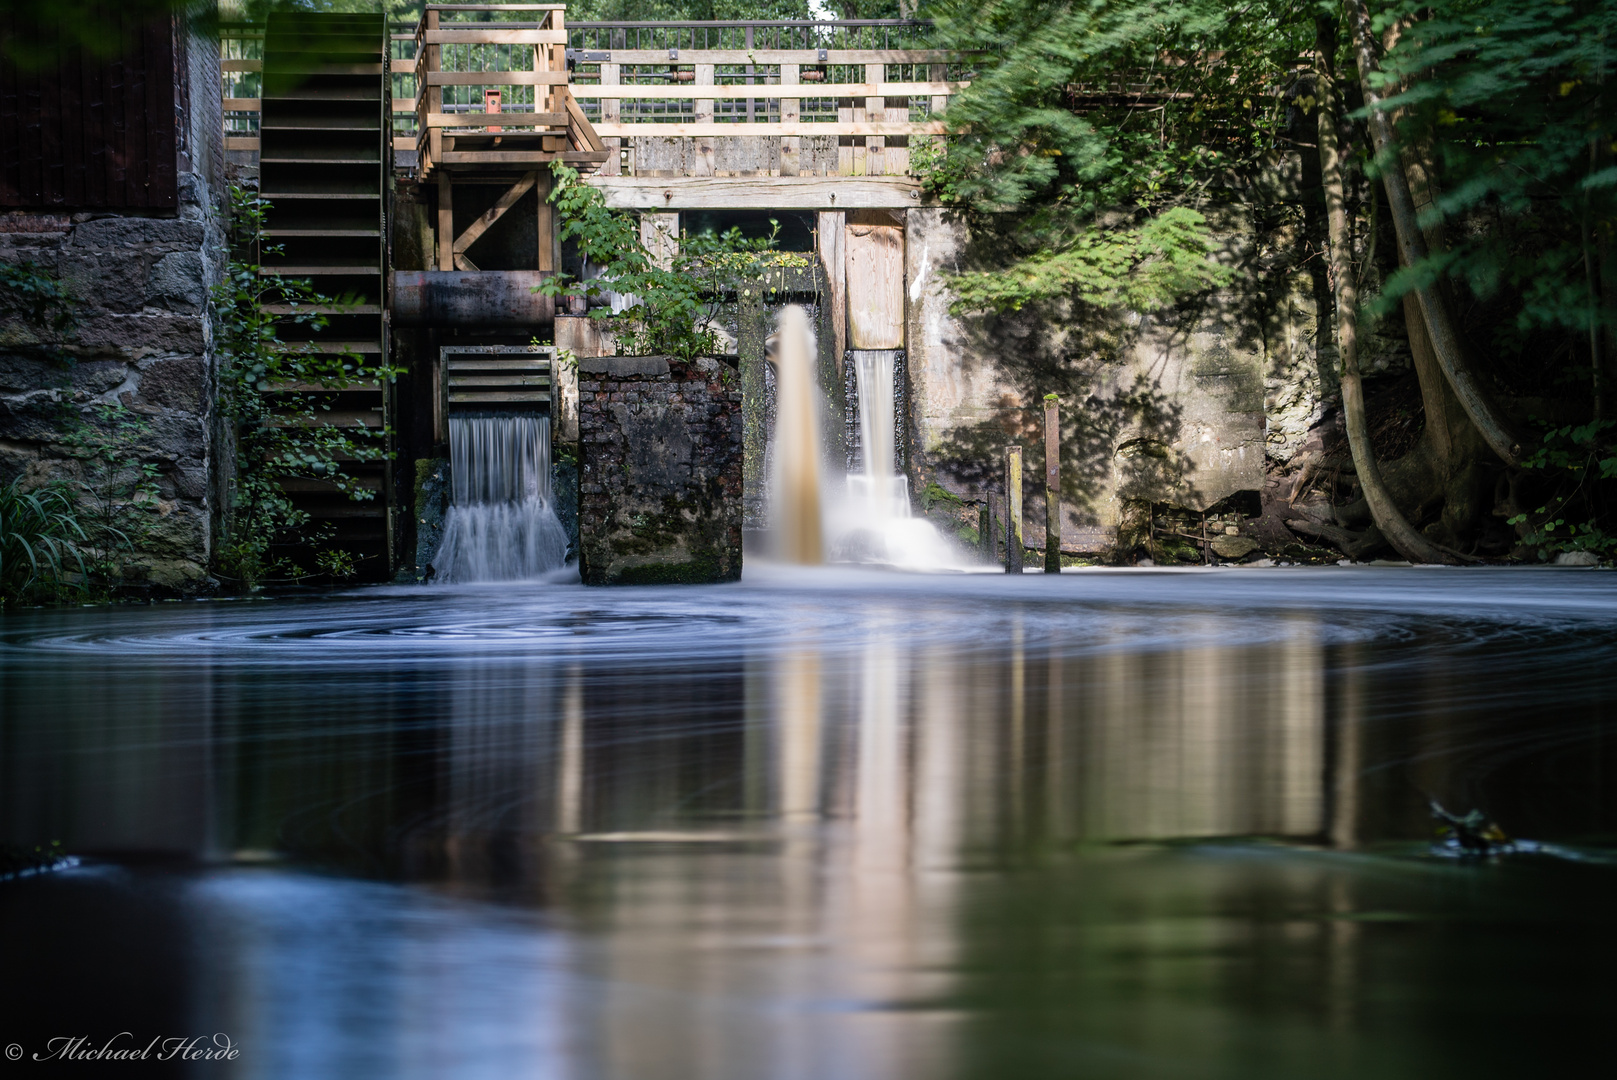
259,11,391,580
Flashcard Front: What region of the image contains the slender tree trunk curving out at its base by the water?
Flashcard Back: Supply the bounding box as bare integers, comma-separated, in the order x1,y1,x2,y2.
1316,16,1454,563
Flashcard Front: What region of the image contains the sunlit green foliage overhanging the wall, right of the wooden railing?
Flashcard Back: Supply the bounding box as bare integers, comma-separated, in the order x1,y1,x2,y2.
910,0,1313,310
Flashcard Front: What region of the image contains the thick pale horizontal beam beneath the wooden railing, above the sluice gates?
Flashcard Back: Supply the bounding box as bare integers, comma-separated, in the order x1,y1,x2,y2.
585,176,920,210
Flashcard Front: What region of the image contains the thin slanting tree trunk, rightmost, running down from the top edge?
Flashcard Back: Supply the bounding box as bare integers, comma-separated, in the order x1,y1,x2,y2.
1342,0,1523,466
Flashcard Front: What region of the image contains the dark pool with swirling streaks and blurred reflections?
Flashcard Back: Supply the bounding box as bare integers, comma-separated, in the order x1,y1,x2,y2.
0,569,1617,1080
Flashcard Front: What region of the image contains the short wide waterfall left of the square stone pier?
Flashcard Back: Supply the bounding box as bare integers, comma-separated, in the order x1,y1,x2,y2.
432,416,568,584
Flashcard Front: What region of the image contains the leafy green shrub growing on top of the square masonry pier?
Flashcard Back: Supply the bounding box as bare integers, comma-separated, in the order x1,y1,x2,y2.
538,162,809,361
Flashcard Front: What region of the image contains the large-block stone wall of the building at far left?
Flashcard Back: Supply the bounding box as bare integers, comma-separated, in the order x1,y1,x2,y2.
0,189,222,592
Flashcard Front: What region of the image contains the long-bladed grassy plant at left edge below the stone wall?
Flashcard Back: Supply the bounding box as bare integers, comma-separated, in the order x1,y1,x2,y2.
0,479,89,606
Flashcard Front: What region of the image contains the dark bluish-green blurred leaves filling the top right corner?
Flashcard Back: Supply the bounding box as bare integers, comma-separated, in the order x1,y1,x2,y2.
1378,0,1617,347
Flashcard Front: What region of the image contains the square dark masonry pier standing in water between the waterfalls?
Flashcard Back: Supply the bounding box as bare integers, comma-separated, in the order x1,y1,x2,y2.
579,356,742,585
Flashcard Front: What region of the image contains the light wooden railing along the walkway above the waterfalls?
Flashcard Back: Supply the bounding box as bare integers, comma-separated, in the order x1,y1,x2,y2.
223,3,970,178
